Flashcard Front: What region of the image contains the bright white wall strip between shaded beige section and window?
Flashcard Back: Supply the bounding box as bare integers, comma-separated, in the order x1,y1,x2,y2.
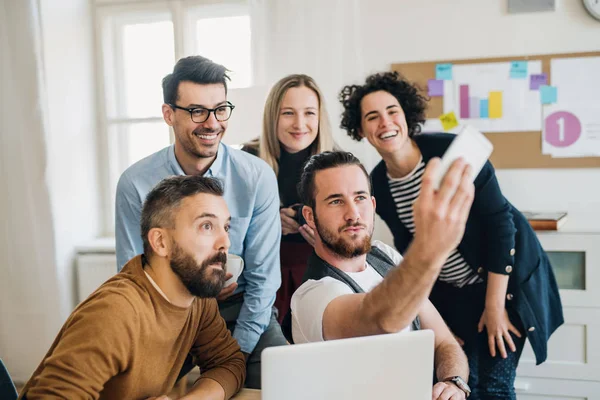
40,0,101,317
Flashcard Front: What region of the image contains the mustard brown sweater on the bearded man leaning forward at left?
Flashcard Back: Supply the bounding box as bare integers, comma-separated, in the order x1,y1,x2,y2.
21,256,246,400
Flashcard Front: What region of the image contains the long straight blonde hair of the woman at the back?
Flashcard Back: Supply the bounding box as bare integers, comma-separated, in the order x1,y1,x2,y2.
258,74,335,175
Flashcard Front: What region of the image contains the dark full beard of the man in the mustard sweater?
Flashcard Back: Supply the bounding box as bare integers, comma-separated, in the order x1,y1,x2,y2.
170,242,227,298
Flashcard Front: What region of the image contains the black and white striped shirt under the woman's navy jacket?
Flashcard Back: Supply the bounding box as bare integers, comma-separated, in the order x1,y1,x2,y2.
388,158,481,287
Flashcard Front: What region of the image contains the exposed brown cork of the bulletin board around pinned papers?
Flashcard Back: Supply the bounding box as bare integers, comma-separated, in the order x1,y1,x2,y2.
392,52,600,169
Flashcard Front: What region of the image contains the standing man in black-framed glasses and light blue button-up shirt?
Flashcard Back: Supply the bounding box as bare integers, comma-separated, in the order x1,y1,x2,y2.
115,56,286,388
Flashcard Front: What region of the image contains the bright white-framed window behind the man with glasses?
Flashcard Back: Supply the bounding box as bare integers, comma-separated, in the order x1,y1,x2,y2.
96,0,253,234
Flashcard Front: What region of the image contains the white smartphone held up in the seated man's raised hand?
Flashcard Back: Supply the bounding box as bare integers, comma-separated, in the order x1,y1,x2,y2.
433,125,494,190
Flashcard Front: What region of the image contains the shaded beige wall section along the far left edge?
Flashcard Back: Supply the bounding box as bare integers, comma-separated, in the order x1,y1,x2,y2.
0,2,59,378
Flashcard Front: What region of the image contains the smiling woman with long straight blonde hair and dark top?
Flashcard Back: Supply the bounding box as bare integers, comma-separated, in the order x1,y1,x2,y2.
243,75,335,322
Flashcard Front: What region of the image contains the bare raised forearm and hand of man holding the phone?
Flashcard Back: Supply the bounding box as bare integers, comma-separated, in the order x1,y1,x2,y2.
323,159,474,340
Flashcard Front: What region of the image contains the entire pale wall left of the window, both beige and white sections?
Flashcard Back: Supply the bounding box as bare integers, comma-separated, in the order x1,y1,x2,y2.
0,0,100,382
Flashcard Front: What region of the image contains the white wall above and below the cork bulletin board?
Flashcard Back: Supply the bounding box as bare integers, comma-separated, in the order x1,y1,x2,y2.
360,0,600,240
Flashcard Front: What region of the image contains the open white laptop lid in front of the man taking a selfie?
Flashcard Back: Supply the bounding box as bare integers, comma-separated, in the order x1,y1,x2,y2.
261,330,434,400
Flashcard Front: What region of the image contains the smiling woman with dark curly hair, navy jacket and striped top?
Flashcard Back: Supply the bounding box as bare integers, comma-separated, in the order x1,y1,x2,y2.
339,72,563,399
